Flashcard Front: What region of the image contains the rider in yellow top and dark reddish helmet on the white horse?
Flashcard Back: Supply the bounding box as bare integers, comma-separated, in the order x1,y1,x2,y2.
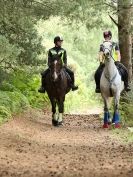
95,31,131,93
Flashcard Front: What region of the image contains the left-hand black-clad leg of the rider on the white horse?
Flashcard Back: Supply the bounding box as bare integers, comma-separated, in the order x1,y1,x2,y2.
94,64,105,93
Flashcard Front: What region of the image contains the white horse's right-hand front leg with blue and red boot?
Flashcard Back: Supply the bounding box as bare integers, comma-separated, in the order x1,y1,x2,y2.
112,93,120,128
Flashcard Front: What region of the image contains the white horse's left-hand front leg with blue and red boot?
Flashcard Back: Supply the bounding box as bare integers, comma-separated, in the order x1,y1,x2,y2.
103,97,111,128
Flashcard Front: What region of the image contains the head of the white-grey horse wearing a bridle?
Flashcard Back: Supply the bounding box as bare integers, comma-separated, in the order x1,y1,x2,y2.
102,41,113,59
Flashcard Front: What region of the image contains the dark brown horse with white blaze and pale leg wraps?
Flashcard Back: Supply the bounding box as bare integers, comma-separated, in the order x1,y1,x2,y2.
45,54,71,126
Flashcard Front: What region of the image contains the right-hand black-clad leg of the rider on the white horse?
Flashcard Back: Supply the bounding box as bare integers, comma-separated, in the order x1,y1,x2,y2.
115,62,131,91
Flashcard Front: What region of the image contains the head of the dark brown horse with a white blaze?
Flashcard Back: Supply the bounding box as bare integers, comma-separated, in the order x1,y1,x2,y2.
50,54,63,82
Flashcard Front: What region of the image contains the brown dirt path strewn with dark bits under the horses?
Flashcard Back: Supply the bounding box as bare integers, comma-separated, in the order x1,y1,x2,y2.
0,110,133,177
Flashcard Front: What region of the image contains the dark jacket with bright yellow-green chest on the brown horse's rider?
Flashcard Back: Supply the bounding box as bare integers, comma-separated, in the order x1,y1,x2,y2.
48,46,67,66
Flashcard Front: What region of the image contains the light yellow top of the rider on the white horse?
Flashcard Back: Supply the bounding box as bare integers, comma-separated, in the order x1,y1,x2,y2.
99,41,120,63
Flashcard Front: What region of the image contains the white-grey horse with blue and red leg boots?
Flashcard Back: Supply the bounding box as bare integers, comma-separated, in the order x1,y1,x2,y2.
100,41,124,128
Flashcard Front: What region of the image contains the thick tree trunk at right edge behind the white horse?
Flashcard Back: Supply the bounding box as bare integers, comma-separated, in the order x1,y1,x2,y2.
118,0,132,81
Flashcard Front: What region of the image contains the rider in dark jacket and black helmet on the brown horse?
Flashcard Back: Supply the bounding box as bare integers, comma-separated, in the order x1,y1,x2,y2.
38,36,78,93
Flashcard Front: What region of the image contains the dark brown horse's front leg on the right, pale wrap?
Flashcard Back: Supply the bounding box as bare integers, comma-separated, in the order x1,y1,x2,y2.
58,97,65,125
